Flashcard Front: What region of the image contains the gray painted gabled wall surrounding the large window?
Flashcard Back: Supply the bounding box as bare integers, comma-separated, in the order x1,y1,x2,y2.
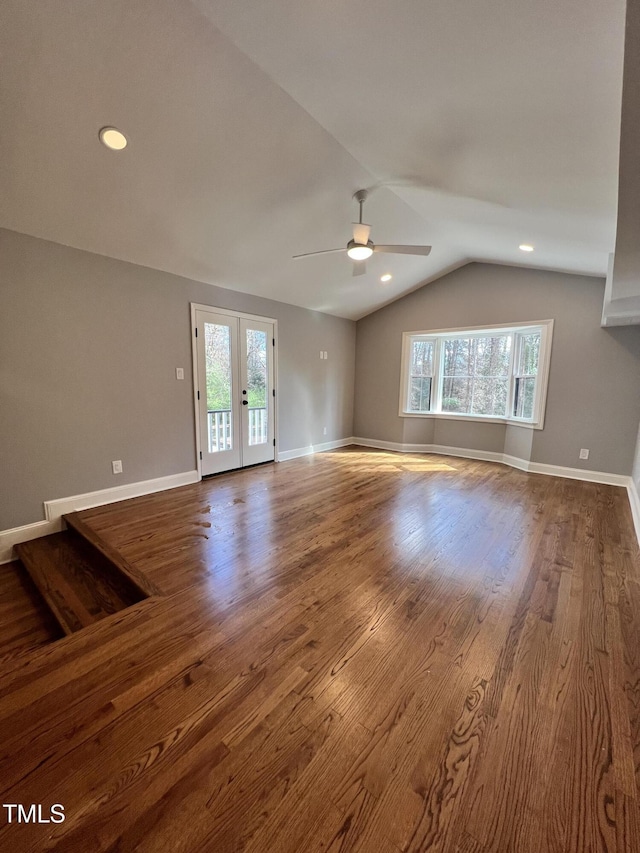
354,264,640,474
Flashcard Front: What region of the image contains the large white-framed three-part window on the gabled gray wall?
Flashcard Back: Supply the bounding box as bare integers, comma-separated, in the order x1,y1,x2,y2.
400,320,553,428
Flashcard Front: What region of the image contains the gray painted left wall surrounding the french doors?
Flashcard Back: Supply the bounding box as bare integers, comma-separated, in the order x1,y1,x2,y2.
0,230,355,530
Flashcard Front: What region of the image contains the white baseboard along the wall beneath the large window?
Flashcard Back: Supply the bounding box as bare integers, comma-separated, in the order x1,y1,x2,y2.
352,437,631,488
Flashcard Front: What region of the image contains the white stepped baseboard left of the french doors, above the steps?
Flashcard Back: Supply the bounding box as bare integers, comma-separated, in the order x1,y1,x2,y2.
0,471,201,564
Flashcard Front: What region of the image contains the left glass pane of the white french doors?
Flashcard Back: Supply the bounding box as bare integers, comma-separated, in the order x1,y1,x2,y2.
204,323,233,453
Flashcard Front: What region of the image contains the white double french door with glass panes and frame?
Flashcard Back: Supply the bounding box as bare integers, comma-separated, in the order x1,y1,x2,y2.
193,307,275,476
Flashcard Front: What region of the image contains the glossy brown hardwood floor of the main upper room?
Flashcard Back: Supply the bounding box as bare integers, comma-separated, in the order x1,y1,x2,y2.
0,449,640,853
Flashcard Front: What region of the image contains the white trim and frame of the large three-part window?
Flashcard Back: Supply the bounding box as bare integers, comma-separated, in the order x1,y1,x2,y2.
398,320,553,429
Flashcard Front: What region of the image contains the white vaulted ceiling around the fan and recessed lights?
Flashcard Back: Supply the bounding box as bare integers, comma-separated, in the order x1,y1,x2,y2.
0,0,625,318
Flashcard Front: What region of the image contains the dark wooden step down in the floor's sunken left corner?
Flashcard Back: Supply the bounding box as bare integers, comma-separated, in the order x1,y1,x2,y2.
16,530,146,634
